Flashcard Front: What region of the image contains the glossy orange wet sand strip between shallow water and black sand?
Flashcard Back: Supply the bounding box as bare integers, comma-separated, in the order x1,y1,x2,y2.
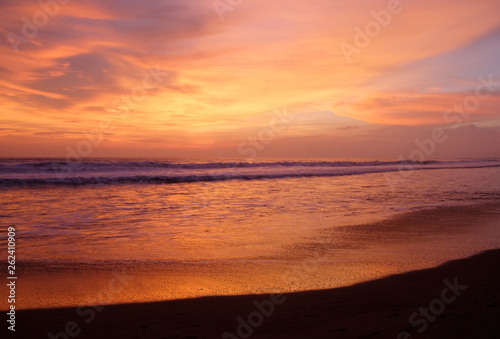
0,204,500,310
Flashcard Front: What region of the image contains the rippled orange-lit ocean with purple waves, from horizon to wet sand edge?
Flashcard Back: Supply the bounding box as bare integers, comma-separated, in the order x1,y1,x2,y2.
0,159,500,263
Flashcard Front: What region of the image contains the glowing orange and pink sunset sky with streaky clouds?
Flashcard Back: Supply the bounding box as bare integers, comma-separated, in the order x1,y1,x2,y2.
0,0,500,160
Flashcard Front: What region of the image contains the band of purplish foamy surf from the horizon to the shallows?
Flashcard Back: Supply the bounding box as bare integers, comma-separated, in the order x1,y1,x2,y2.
0,159,500,186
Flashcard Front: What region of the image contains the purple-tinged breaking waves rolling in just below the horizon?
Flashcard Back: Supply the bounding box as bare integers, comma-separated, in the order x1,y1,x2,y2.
0,161,500,187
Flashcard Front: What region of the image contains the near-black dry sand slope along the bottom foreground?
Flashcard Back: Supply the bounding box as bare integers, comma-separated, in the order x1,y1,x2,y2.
12,250,500,339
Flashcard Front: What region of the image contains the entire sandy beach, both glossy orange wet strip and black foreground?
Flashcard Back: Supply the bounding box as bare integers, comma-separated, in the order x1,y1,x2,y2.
2,204,500,338
